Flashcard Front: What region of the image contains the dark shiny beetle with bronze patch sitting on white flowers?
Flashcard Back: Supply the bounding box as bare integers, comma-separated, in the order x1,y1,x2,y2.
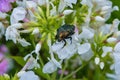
55,24,75,47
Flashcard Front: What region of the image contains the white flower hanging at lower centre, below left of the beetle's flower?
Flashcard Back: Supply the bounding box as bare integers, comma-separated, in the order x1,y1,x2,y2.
43,58,62,73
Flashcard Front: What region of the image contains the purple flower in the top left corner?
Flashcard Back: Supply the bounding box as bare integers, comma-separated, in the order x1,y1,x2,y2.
0,0,15,12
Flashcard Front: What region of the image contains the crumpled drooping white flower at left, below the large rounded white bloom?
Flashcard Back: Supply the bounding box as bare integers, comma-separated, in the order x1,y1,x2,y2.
5,23,30,46
